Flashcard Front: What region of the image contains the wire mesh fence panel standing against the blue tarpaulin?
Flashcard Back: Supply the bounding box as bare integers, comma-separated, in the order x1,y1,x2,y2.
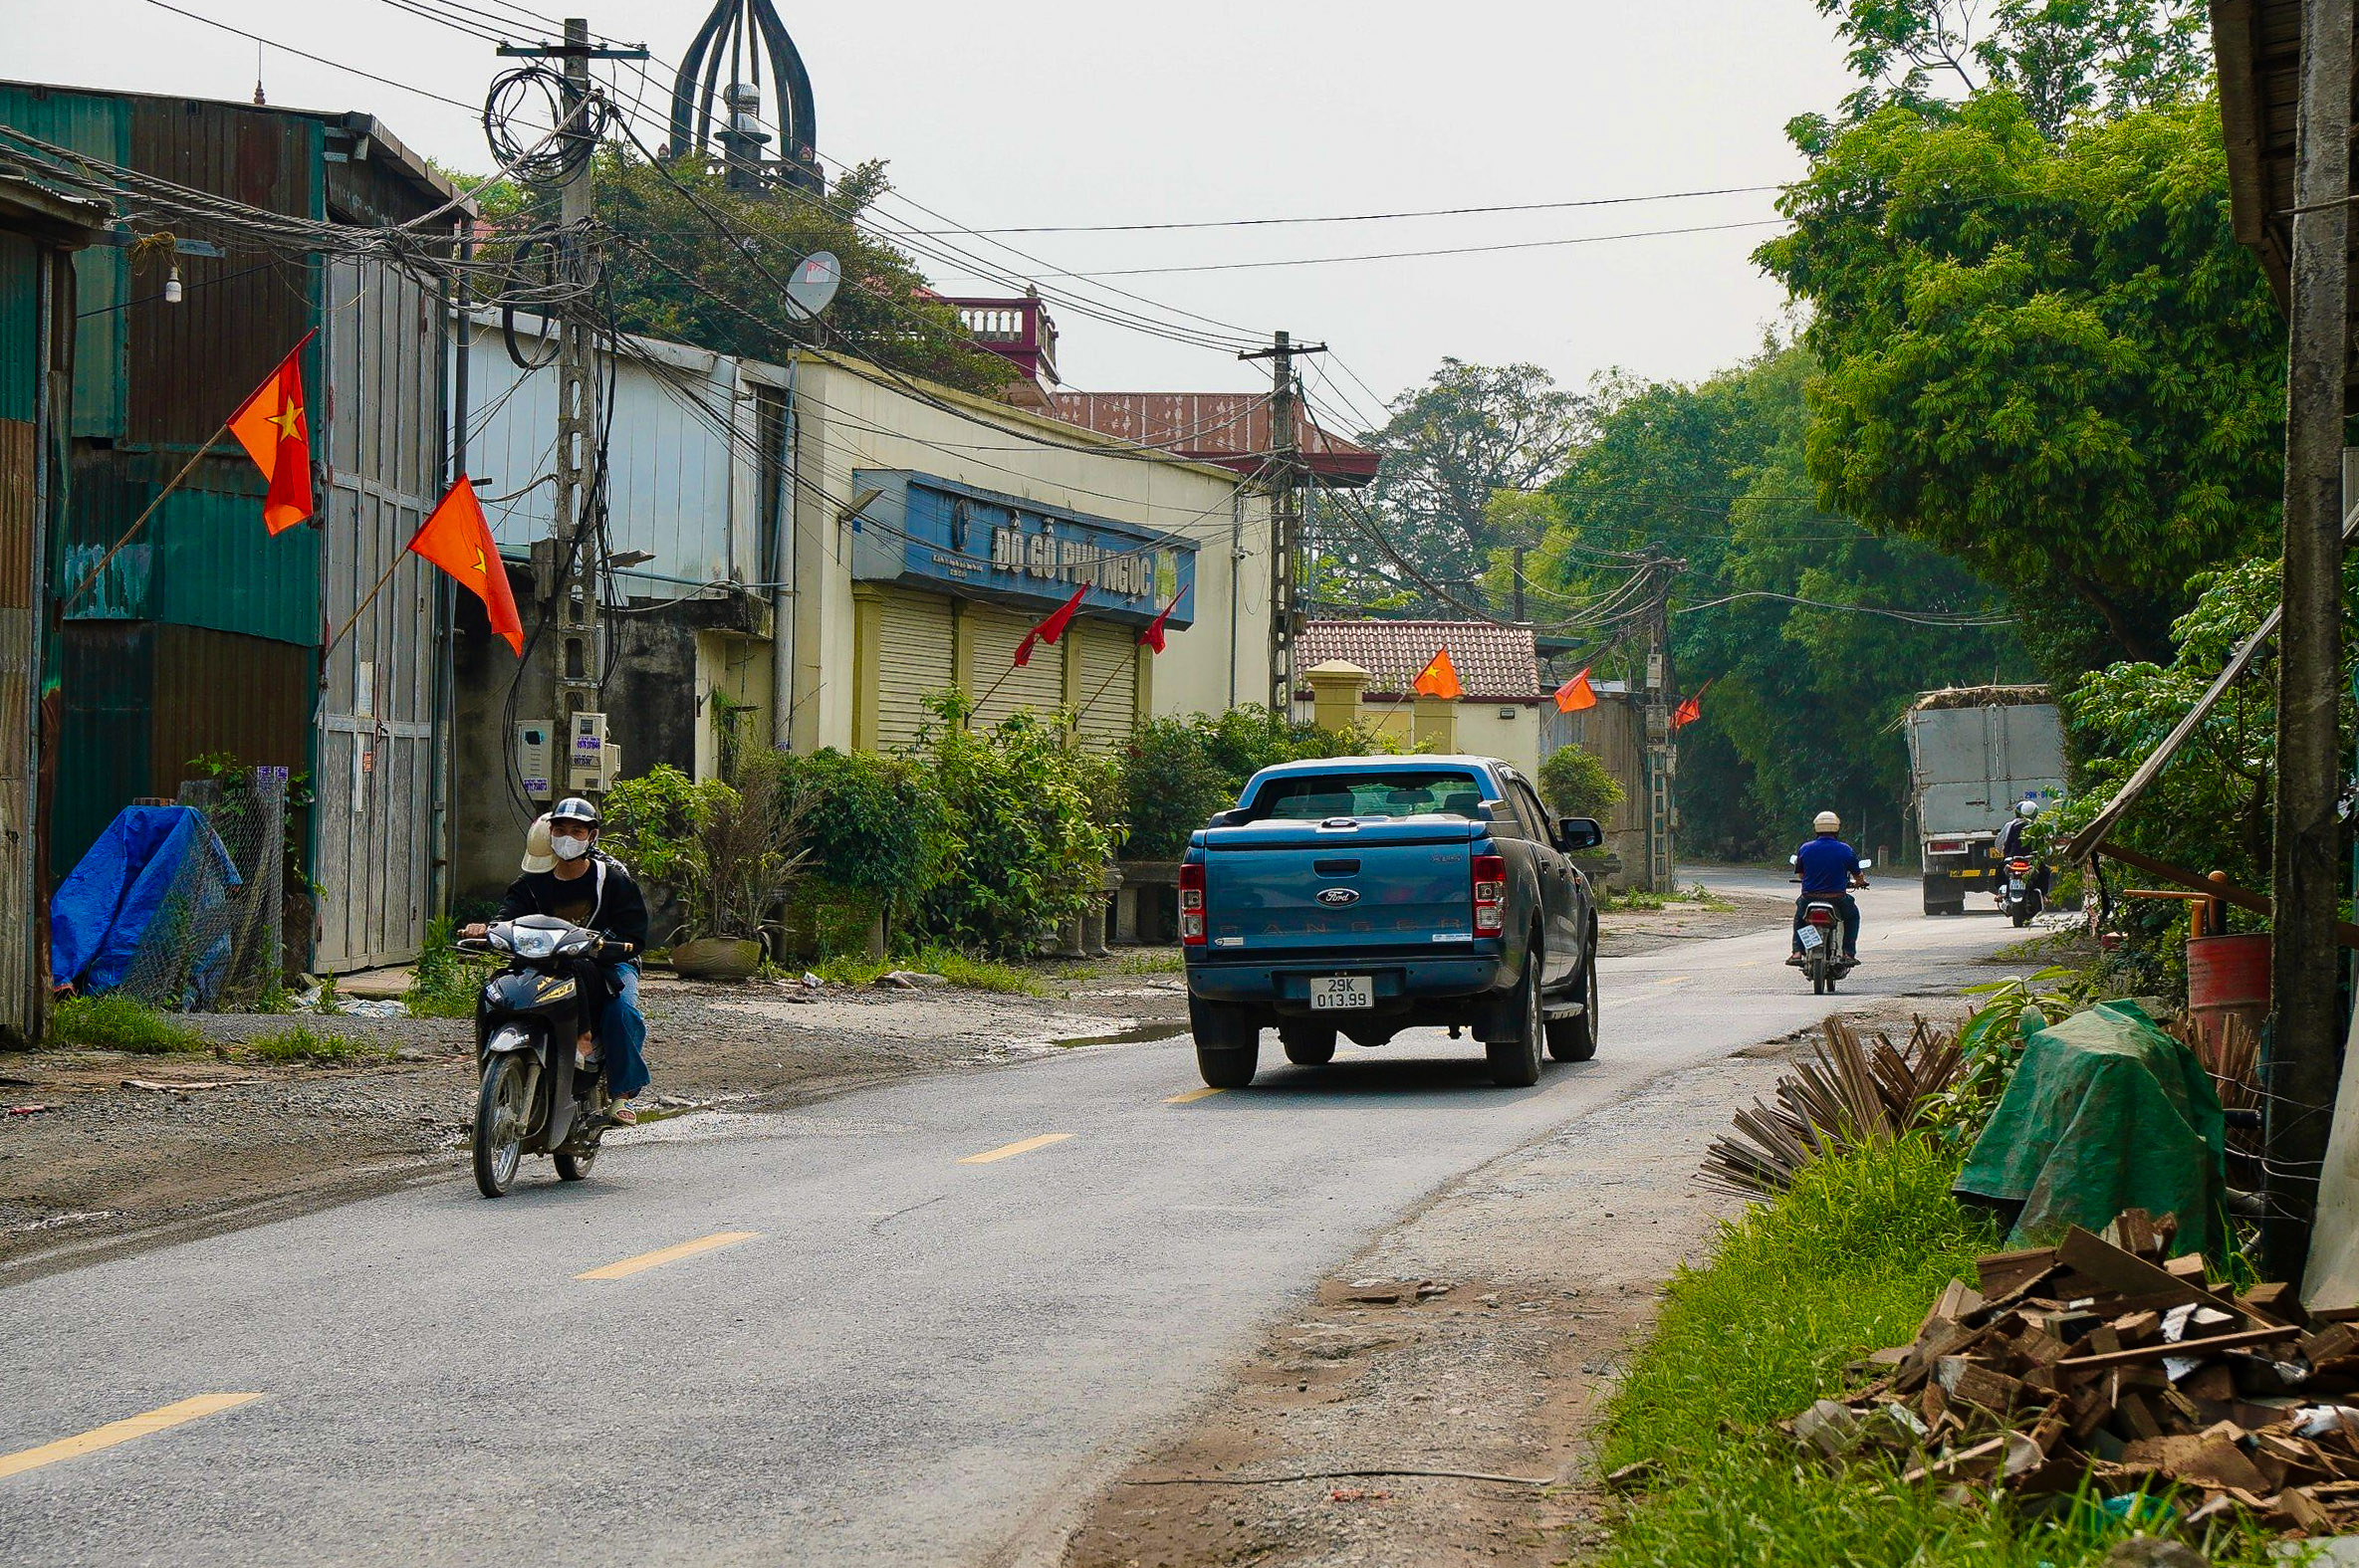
122,769,288,1009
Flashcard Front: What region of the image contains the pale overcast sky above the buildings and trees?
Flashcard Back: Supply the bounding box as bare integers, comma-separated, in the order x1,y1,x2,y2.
0,0,1845,429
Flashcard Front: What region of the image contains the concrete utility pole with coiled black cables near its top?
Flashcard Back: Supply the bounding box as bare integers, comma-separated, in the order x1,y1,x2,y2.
500,17,646,794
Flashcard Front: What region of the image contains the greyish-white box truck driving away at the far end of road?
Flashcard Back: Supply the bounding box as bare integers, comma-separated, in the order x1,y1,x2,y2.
1904,686,2064,915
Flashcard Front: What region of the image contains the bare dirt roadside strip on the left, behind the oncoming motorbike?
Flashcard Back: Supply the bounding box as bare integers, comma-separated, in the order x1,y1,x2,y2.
0,960,1187,1278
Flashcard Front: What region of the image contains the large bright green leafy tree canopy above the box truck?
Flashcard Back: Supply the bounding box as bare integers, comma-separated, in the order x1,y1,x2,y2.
1758,90,2283,674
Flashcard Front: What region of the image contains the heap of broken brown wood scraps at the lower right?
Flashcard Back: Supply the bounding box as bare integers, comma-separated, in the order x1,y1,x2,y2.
1785,1210,2359,1535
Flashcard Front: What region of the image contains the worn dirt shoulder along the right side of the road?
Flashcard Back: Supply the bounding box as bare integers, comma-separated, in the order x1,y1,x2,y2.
1063,1011,1944,1568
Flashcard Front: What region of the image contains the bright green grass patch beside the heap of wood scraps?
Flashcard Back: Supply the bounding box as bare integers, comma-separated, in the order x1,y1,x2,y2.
1597,1137,2269,1568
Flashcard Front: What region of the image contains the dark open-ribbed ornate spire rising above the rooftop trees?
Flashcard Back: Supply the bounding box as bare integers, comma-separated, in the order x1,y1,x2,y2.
665,0,828,193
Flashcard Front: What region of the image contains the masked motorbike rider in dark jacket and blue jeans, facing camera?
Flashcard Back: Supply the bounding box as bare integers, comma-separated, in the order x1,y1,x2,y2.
465,794,648,1127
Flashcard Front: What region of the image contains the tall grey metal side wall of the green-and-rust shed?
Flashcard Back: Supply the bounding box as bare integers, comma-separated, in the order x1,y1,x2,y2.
312,247,443,969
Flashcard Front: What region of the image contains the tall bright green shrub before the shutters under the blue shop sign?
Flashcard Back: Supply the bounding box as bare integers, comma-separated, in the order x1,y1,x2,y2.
915,691,1118,958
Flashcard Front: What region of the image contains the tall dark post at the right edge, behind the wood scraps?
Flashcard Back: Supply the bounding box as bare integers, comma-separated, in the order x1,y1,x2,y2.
2262,0,2352,1280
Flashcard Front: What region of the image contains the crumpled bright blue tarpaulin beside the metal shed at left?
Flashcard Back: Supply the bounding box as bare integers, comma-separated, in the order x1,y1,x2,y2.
50,806,238,1005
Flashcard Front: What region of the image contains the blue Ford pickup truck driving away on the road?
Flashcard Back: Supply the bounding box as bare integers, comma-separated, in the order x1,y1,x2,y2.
1180,757,1604,1089
